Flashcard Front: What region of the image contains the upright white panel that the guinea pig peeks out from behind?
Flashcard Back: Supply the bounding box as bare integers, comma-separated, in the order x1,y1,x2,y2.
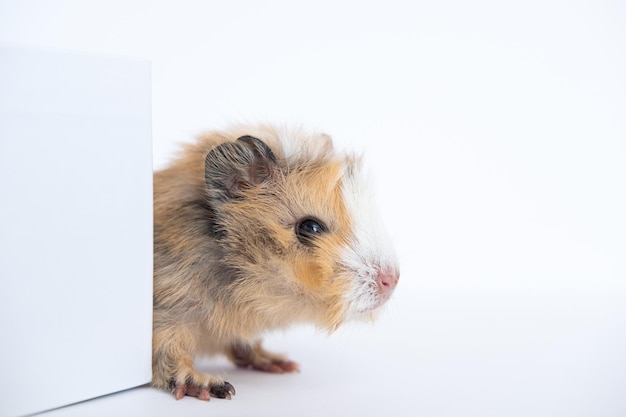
0,48,152,416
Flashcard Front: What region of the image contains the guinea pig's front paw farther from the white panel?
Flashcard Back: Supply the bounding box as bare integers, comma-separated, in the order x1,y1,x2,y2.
226,342,300,374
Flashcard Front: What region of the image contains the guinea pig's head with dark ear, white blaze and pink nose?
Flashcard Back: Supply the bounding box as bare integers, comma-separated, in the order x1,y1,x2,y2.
205,132,399,330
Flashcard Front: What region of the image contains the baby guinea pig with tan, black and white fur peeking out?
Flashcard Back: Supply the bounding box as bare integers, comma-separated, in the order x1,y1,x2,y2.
152,126,399,400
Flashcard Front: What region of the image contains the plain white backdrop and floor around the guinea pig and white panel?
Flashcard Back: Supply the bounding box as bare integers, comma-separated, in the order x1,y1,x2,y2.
0,0,626,416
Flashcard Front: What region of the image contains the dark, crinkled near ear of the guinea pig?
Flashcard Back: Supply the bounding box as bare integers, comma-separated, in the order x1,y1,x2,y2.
204,136,278,201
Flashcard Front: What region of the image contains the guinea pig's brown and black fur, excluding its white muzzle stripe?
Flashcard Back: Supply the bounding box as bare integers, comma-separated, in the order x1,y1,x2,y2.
153,126,358,399
